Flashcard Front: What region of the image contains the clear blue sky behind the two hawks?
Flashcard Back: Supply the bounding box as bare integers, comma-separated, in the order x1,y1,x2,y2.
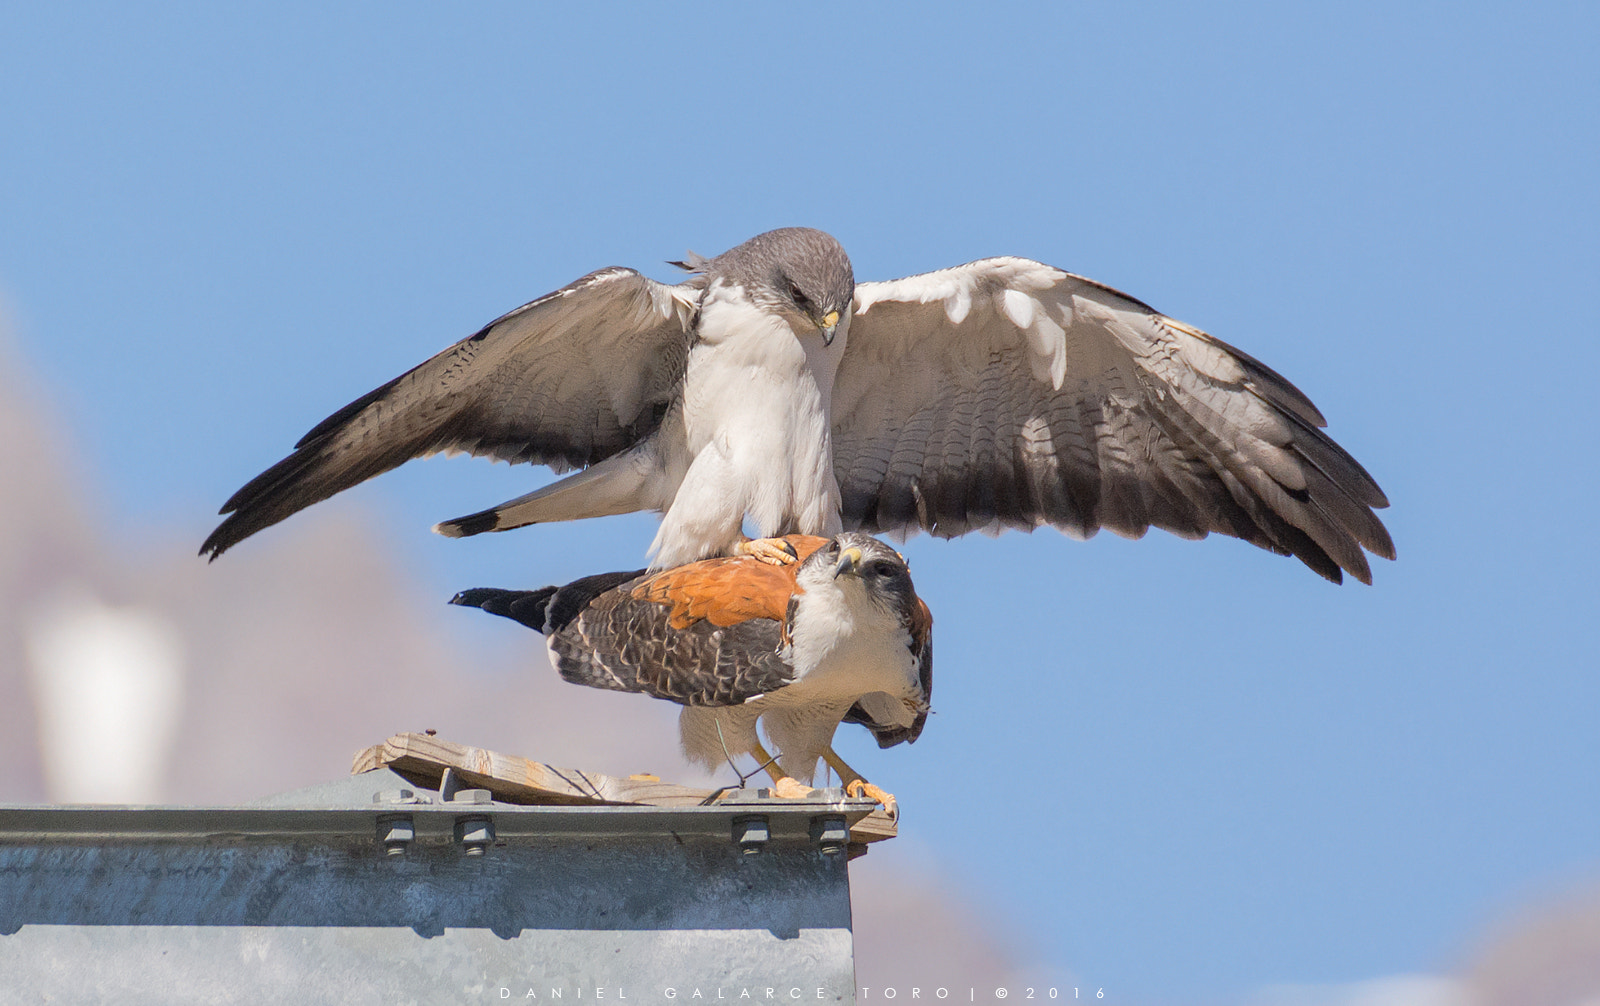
0,3,1600,1003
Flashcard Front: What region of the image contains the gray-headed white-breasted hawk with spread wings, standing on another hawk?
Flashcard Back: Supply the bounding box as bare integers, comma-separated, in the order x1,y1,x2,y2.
202,227,1394,582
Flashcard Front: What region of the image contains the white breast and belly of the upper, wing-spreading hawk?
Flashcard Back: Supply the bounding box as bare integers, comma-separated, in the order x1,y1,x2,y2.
650,280,850,568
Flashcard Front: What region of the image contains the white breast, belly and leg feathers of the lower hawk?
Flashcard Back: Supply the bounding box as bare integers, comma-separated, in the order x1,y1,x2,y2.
678,565,925,782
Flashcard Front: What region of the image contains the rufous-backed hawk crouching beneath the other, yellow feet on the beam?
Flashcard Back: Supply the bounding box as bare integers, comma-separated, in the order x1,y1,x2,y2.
451,533,933,808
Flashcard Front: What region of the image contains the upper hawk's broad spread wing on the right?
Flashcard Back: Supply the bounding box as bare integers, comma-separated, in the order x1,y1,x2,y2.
832,257,1394,582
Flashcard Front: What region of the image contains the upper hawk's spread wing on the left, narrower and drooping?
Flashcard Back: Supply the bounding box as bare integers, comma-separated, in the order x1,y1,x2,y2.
200,269,701,558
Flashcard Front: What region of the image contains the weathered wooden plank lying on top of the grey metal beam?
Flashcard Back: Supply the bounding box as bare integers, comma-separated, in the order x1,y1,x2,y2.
350,734,896,843
